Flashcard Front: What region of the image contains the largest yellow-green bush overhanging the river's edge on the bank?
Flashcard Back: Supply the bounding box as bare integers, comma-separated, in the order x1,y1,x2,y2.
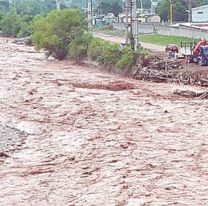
32,9,86,60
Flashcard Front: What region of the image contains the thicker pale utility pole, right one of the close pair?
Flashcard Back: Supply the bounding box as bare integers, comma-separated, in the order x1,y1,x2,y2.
131,0,138,52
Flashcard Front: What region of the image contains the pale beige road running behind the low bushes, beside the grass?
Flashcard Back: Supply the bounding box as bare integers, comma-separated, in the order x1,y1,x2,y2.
93,32,165,52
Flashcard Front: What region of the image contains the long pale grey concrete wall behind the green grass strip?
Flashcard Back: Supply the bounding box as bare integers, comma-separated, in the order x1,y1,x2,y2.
113,23,208,39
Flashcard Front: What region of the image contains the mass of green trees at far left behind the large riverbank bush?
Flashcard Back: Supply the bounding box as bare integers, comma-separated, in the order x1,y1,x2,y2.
0,0,86,37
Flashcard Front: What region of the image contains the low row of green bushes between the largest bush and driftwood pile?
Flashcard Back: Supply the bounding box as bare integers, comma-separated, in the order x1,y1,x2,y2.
69,34,143,71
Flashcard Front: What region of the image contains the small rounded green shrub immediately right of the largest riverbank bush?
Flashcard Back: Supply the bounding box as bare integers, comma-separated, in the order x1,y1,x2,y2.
68,33,93,61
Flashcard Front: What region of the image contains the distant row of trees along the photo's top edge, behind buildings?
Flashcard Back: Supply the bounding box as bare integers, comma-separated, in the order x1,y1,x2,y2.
0,0,208,21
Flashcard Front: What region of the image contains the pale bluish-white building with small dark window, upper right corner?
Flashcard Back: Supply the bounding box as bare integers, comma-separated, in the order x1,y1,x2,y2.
192,4,208,22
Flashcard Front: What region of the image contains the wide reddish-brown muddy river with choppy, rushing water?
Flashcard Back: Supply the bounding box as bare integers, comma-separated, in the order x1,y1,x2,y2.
0,38,208,206
